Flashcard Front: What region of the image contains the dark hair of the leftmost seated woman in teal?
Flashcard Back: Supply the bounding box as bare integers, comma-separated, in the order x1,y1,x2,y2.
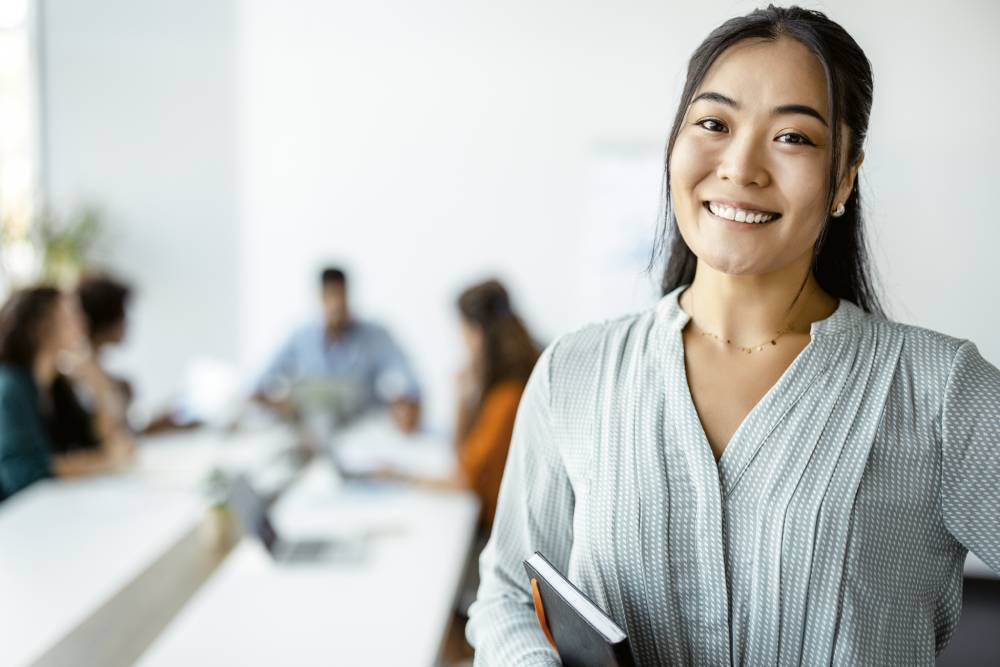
0,286,62,372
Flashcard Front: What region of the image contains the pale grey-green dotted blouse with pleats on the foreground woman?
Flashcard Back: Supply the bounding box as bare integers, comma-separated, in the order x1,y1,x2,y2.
467,287,1000,667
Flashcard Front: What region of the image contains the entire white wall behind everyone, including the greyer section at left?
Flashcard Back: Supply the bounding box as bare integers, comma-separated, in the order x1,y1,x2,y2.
47,0,1000,423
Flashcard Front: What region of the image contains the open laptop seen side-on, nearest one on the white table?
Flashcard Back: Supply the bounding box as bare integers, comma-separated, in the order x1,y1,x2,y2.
229,475,364,563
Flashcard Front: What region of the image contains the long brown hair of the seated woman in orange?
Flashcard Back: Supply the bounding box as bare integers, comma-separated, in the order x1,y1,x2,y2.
458,280,539,394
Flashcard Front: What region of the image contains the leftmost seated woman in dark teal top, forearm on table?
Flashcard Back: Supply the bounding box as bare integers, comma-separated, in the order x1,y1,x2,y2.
0,287,131,500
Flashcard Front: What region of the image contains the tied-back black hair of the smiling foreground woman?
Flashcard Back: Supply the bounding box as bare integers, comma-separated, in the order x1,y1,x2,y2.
654,5,883,314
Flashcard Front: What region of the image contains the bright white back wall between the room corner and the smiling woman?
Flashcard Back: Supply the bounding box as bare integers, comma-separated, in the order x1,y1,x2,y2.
239,0,681,428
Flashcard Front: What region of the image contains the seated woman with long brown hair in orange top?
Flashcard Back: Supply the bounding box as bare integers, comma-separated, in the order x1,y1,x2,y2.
455,280,539,532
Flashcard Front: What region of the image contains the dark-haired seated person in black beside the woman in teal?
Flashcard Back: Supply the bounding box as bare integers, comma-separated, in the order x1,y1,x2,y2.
48,276,132,452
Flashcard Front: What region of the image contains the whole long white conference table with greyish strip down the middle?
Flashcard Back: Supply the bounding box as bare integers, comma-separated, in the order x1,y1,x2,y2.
0,426,477,667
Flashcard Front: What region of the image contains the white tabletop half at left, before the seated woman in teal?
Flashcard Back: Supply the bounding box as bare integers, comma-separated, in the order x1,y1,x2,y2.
0,429,289,665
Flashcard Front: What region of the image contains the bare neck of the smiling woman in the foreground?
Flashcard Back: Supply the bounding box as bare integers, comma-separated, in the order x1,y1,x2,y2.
682,262,837,345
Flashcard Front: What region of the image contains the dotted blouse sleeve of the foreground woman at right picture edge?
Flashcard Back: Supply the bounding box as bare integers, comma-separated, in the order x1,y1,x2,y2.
941,341,1000,573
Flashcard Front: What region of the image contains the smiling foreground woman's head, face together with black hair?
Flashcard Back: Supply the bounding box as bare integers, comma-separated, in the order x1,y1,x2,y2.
661,11,882,313
